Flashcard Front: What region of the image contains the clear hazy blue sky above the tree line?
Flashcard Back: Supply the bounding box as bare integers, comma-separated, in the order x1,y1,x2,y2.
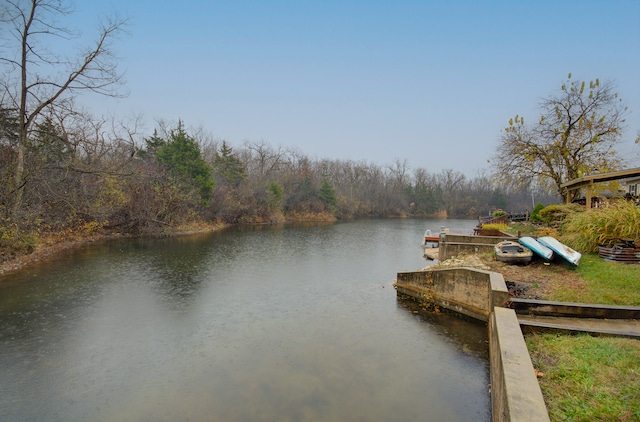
74,0,640,176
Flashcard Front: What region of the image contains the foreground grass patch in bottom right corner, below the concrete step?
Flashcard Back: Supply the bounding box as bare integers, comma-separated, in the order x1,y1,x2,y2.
526,334,640,421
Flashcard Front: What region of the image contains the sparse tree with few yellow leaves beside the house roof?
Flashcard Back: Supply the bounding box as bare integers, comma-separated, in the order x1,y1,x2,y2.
493,75,627,199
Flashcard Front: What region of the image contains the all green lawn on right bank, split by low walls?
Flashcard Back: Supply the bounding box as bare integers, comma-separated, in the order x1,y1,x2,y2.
510,217,640,421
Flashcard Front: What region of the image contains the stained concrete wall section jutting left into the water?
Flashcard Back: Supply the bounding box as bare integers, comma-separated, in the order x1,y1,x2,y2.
396,268,509,321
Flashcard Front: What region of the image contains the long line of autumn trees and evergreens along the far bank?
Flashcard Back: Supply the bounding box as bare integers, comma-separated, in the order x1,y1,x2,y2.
0,108,552,237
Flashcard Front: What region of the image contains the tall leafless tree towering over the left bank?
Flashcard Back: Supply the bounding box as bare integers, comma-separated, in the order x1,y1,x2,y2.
0,0,126,214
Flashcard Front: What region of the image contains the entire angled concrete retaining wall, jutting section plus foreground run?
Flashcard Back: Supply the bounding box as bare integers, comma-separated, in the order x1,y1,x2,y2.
396,268,549,421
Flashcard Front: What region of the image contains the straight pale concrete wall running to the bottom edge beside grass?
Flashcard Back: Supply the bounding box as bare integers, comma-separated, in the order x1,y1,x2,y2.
489,307,549,421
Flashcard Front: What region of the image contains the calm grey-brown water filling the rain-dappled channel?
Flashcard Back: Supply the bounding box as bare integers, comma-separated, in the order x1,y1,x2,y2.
0,220,490,421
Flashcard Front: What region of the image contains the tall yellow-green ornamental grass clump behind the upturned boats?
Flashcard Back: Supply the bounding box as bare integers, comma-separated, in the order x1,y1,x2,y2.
562,201,640,252
